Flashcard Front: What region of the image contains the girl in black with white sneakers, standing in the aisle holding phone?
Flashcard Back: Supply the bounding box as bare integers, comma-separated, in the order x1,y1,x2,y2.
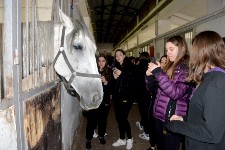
112,49,134,150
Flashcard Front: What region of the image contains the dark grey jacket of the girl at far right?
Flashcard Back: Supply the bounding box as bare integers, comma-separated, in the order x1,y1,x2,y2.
167,71,225,150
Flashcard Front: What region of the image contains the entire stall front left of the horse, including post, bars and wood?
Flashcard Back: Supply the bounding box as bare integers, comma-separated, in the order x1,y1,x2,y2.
0,0,62,150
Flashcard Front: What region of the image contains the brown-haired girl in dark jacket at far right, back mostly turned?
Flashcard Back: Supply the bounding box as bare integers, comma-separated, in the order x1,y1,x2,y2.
167,31,225,150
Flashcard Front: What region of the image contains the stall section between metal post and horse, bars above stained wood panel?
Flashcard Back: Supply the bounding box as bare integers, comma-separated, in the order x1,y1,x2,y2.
22,0,62,149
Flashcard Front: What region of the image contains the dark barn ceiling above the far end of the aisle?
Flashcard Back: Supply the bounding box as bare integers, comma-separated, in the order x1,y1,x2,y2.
87,0,148,43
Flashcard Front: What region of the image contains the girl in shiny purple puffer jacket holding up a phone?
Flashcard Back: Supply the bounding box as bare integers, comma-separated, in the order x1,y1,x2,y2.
146,36,190,150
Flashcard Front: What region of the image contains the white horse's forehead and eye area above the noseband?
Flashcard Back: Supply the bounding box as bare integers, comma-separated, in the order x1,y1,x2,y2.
58,18,98,74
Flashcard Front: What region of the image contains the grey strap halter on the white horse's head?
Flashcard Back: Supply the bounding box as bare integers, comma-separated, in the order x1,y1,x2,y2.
53,26,101,90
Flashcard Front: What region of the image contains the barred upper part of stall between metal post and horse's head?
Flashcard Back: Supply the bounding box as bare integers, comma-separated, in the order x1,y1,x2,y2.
22,1,57,91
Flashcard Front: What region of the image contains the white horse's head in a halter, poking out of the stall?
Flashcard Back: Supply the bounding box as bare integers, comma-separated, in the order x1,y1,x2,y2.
54,3,103,110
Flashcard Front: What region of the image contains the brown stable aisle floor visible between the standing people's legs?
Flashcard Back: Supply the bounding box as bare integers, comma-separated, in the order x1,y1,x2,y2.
73,104,150,150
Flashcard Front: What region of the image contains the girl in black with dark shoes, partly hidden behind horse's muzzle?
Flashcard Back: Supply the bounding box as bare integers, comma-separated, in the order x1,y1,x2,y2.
86,54,113,150
